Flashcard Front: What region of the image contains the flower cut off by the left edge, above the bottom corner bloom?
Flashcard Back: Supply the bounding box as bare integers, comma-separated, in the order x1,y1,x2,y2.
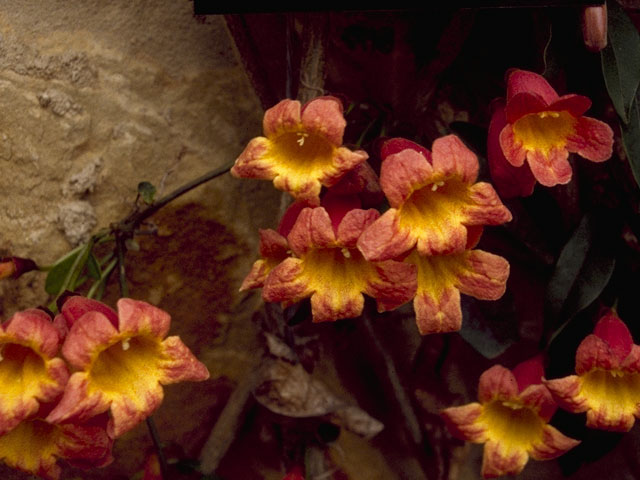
0,309,69,434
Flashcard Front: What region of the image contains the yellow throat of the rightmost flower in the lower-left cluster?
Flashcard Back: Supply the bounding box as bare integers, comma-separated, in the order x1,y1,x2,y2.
89,336,163,400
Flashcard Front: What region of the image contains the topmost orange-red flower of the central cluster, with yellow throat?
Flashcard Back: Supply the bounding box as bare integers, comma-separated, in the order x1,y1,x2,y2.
231,97,368,206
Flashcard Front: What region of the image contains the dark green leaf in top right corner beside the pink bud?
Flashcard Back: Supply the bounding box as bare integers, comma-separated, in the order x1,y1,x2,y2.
601,0,640,123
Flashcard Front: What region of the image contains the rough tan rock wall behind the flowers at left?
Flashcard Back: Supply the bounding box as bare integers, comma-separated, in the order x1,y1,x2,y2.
0,0,279,478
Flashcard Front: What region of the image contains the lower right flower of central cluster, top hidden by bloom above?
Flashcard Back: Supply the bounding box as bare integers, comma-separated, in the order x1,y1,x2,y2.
405,250,509,335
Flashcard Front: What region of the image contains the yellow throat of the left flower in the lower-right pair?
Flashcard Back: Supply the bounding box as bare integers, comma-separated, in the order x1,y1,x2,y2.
478,400,545,451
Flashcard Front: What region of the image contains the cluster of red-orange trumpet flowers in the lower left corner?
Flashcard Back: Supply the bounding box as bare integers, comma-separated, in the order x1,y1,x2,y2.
0,296,209,480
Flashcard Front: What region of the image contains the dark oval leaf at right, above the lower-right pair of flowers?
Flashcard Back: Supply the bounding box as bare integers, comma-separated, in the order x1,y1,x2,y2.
546,214,615,325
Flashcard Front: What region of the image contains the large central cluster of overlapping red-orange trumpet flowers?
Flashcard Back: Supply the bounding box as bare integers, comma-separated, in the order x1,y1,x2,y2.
231,97,511,334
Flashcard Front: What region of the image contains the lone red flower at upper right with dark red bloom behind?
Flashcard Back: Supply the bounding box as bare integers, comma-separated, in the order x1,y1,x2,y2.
487,70,613,197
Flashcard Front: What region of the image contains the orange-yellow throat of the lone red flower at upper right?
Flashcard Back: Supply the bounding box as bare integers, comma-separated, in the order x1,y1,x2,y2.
513,111,577,154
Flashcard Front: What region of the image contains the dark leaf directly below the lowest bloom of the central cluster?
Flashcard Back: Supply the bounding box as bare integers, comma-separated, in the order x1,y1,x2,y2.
459,294,518,359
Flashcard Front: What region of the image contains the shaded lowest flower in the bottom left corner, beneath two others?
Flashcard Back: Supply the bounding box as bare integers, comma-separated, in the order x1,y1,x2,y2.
0,408,113,480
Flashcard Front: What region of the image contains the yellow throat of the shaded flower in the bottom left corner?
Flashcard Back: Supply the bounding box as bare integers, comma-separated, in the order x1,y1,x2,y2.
0,419,62,473
